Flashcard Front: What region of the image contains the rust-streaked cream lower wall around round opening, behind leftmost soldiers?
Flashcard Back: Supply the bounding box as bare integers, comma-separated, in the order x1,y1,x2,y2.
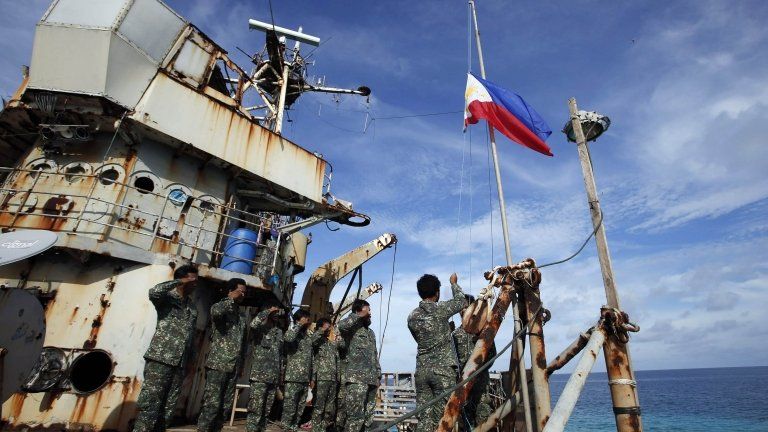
0,255,213,430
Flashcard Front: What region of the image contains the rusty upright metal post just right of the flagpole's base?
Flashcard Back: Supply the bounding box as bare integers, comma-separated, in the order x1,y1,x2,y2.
523,285,552,431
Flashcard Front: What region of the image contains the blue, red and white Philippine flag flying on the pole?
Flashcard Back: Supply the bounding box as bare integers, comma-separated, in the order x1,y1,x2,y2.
464,73,552,156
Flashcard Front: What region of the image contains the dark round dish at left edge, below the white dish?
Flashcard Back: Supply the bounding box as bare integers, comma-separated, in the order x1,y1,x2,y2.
0,288,45,402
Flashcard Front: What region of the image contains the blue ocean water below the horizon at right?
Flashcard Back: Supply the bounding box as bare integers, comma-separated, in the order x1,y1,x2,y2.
551,366,768,432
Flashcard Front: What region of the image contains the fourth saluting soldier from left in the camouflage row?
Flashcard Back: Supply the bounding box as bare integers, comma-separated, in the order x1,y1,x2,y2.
280,309,321,428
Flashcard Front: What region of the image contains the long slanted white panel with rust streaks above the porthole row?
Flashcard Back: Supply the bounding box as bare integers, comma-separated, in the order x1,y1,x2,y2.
131,73,325,202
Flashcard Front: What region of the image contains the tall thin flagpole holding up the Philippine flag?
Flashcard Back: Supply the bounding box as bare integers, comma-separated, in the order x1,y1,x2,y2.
469,0,532,432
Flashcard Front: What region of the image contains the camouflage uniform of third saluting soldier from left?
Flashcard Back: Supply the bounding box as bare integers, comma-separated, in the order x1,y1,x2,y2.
245,310,283,432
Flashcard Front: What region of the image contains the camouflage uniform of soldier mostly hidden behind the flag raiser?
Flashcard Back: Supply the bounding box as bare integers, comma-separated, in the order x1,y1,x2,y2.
453,327,496,426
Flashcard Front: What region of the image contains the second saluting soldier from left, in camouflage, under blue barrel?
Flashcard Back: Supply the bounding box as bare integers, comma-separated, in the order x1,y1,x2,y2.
197,278,246,432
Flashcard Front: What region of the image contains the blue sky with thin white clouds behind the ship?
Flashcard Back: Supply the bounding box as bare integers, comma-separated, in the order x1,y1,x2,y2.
0,0,768,371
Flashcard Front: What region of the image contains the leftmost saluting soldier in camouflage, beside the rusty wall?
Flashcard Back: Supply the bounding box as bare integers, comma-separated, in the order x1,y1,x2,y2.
133,265,197,432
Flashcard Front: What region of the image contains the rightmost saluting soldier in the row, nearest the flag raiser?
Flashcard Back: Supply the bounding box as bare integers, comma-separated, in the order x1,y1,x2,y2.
339,299,381,432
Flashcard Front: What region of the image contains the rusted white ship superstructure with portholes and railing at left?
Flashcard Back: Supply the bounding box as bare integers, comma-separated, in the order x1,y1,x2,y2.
0,0,369,430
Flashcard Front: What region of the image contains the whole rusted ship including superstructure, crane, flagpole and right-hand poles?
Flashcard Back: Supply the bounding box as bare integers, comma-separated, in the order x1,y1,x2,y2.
0,0,642,432
